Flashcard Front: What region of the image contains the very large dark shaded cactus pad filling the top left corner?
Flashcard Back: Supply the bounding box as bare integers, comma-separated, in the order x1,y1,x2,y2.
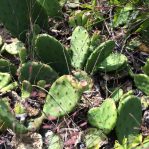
0,0,48,41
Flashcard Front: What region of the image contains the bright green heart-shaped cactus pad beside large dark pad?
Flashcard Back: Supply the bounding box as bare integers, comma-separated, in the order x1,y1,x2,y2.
88,99,117,134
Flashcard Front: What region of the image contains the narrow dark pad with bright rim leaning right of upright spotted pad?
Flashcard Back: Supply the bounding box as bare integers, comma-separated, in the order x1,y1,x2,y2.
85,40,115,73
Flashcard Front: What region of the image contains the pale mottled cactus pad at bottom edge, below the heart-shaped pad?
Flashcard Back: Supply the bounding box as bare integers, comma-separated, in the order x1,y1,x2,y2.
83,128,107,149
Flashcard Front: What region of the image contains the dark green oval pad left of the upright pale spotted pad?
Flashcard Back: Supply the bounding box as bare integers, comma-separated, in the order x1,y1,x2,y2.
35,34,70,74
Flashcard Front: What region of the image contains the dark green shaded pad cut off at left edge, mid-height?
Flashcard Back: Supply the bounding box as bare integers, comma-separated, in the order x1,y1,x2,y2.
0,58,16,75
